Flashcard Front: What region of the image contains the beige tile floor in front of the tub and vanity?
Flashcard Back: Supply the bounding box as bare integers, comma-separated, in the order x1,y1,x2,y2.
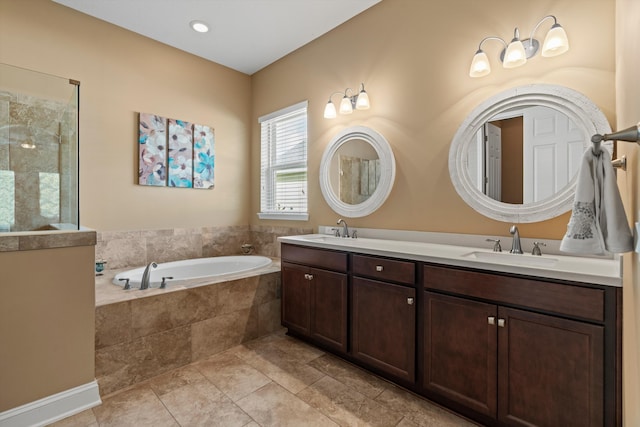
53,331,475,427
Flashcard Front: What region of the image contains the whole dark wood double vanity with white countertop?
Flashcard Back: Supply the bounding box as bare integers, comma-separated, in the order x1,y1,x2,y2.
280,234,622,427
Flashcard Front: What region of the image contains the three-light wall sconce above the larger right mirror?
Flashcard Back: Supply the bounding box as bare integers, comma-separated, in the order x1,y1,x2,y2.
469,15,569,77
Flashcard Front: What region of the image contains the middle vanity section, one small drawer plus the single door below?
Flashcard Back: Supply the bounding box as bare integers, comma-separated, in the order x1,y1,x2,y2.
351,255,417,384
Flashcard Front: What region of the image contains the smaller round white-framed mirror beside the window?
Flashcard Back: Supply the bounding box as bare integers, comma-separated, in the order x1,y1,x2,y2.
320,126,396,218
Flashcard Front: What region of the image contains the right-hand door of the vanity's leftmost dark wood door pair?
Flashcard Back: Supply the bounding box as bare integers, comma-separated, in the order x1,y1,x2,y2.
309,268,347,353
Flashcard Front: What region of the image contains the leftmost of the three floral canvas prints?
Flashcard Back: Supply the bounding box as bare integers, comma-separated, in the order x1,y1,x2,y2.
138,113,167,187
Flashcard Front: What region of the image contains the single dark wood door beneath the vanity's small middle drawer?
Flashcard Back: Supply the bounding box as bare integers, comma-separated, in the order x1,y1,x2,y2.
351,277,416,383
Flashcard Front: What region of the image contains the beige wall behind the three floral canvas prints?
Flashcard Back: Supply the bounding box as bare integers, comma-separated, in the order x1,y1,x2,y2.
0,0,251,231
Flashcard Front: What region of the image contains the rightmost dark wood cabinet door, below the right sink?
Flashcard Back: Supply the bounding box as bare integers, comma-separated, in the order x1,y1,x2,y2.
498,307,604,427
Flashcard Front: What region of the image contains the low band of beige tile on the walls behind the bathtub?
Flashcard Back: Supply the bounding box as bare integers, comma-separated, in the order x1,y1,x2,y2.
96,226,313,269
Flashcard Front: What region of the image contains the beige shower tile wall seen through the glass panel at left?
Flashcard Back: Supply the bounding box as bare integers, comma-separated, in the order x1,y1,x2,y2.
0,91,77,231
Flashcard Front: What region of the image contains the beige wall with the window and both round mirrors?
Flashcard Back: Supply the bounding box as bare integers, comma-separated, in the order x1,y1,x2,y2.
250,0,615,239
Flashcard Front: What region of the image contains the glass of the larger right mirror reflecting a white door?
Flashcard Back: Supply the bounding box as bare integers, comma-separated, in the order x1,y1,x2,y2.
468,106,585,204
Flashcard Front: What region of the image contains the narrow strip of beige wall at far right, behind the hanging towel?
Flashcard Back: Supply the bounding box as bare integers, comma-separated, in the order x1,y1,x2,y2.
613,0,640,427
